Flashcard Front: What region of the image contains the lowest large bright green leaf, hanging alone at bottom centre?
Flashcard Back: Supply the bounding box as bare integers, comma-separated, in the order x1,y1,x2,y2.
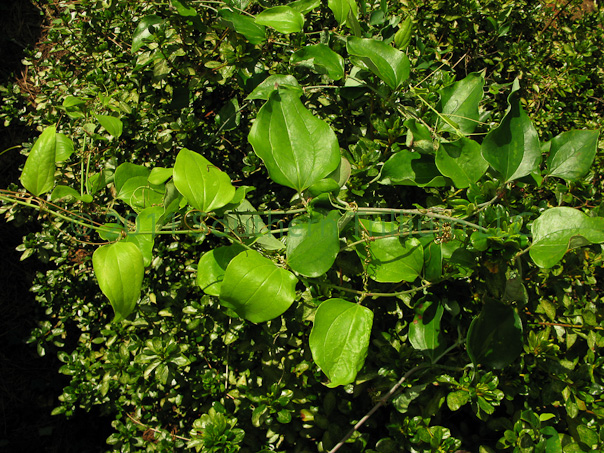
309,299,373,387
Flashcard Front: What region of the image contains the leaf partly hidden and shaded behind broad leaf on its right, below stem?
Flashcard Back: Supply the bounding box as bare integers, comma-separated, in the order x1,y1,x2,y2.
197,244,245,296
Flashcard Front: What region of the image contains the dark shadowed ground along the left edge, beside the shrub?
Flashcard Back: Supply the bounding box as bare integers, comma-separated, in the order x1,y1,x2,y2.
0,0,110,453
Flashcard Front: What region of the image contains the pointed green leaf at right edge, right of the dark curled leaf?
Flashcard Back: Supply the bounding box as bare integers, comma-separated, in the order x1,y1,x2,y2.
546,131,600,181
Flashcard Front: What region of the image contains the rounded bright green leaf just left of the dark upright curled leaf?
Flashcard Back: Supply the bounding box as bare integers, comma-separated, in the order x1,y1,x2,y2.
435,137,489,189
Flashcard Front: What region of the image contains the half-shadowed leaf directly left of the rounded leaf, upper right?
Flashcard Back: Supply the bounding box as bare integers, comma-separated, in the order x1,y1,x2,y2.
380,149,447,187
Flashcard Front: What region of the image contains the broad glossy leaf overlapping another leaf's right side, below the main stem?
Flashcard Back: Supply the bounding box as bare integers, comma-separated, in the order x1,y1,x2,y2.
220,250,298,323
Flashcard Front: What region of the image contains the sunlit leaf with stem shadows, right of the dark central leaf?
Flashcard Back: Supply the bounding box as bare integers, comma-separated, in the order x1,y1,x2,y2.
355,219,424,283
